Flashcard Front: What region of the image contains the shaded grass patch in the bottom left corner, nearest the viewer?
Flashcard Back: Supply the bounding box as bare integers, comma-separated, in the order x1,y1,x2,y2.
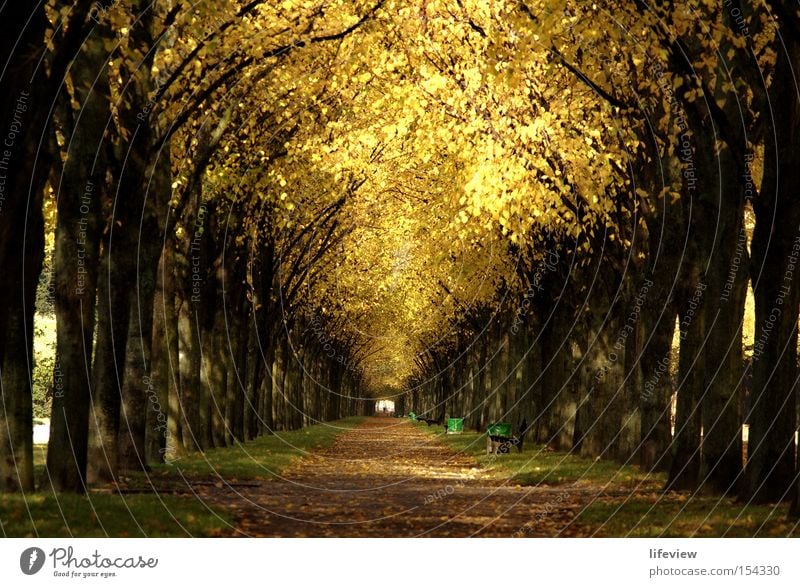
0,493,232,538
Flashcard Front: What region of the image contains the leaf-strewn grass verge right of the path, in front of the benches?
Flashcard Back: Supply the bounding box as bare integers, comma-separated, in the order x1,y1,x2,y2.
415,423,800,537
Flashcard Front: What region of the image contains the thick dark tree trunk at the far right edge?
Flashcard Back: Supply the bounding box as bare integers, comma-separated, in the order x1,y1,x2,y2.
740,35,800,503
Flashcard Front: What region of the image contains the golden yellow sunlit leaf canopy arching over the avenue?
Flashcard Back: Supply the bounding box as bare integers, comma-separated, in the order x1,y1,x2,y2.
114,0,774,396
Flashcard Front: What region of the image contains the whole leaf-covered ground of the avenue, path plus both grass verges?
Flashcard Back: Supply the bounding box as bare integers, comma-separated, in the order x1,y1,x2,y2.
0,417,797,537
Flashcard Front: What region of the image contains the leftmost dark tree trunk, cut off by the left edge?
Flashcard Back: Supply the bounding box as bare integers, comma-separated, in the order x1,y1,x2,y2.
0,2,54,491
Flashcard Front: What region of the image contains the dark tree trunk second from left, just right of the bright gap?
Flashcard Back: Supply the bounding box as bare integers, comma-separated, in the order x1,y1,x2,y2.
45,27,110,492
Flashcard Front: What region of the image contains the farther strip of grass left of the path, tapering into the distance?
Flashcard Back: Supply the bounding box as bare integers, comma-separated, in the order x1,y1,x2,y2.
154,417,364,481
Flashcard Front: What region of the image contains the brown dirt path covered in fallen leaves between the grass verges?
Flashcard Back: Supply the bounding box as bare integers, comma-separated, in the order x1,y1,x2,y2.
196,418,582,537
